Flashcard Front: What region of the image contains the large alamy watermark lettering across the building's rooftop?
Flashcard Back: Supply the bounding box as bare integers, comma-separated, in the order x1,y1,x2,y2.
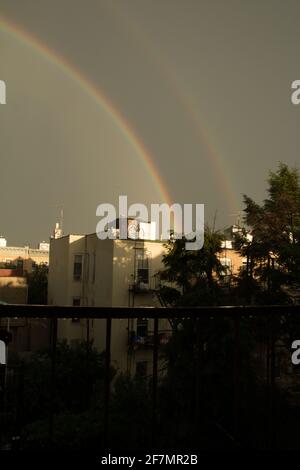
96,195,204,250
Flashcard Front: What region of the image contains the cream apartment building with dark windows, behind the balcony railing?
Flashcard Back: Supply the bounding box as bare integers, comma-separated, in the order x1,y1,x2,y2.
48,224,170,375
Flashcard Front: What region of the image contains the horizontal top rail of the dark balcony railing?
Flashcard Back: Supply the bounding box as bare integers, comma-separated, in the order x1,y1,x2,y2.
0,304,300,319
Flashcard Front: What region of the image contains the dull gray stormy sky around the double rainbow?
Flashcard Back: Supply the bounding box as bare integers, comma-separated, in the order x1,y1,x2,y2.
0,0,300,245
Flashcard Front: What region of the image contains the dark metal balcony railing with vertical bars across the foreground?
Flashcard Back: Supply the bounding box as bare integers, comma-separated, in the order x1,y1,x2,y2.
0,305,300,449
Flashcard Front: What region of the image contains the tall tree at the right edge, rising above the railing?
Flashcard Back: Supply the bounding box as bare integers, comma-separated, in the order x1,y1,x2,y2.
239,163,300,302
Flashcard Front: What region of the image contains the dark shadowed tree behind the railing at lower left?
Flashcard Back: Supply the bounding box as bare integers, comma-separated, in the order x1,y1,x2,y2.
18,341,109,449
